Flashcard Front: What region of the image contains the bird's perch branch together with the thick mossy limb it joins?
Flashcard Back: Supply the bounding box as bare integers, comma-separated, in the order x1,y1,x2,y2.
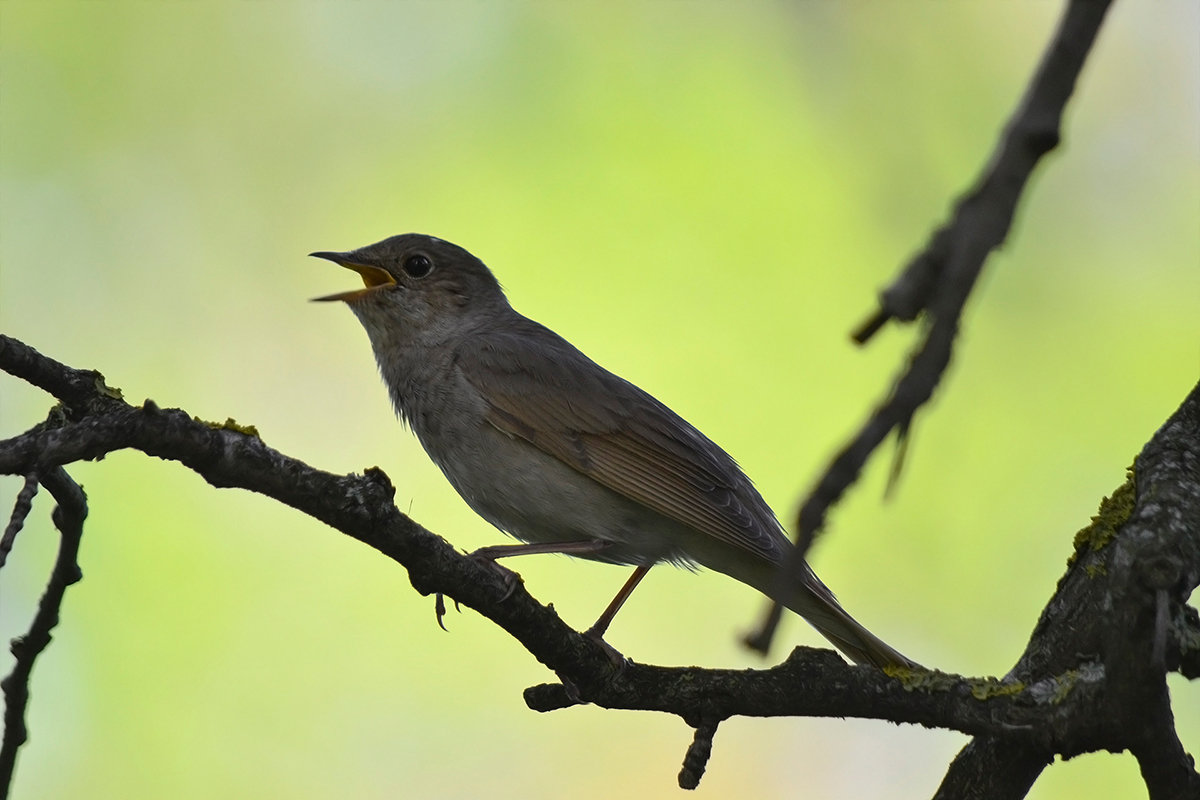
0,336,1200,796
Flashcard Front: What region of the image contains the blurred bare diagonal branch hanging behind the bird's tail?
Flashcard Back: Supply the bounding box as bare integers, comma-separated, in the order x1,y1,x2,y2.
748,0,1109,652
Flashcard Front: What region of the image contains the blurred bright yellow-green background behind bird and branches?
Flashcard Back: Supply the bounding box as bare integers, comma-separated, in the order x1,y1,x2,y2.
0,0,1200,799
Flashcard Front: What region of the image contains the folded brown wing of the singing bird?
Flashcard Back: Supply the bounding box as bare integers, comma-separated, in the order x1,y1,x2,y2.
457,317,787,561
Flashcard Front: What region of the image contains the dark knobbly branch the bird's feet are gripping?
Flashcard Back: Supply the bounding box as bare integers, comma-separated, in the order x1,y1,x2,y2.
0,337,1051,732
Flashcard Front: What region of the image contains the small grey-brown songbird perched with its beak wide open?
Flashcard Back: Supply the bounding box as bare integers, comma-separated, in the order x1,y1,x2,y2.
311,233,916,667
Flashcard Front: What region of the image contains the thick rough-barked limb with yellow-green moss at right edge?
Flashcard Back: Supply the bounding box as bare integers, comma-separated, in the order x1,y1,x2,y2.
937,384,1200,798
